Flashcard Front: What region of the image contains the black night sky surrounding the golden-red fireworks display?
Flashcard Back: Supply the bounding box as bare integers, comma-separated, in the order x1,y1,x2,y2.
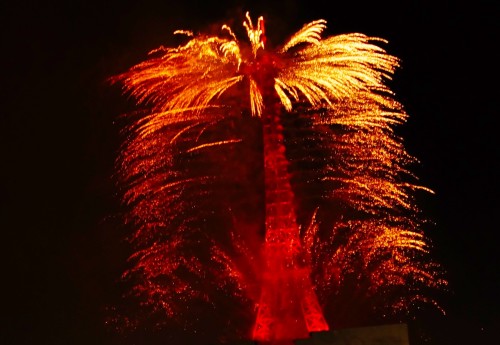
0,0,500,345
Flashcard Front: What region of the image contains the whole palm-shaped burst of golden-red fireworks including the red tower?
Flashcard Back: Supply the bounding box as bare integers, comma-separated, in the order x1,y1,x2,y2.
113,13,446,341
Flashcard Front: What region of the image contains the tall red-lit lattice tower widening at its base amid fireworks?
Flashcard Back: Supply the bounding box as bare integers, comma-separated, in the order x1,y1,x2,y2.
249,46,328,342
